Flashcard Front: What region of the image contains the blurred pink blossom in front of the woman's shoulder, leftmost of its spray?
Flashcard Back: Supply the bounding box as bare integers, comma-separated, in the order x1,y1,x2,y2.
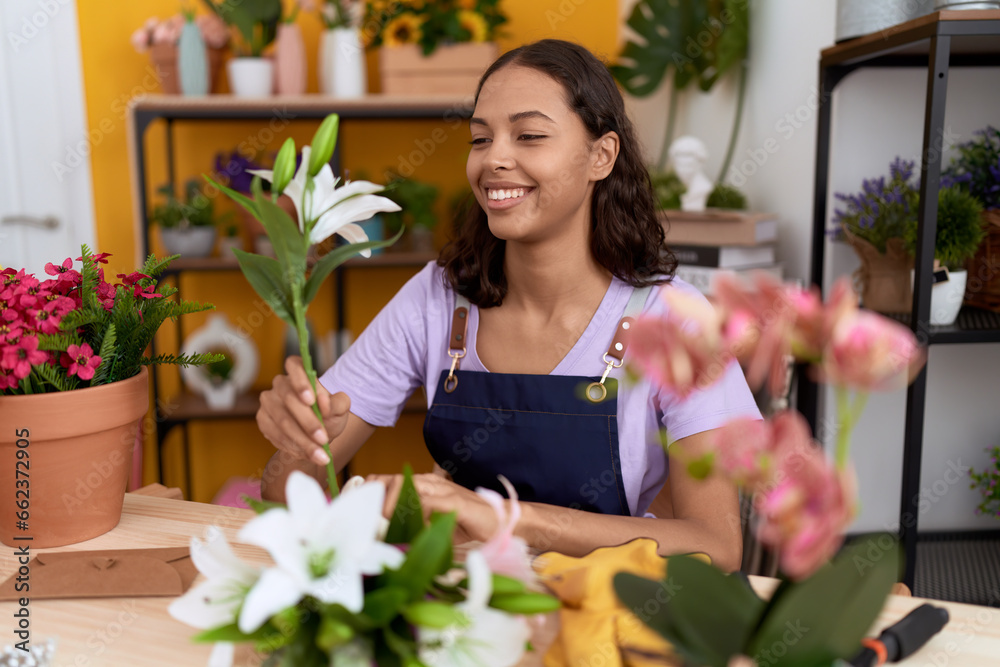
628,287,730,398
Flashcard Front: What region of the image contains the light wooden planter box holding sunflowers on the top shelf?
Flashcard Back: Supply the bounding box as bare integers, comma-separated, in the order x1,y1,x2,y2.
378,42,498,95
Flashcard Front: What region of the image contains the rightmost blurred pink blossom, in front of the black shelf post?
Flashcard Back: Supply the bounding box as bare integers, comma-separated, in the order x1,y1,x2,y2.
822,310,925,391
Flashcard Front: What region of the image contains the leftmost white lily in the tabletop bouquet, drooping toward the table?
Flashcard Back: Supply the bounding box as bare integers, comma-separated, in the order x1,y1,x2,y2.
167,526,260,667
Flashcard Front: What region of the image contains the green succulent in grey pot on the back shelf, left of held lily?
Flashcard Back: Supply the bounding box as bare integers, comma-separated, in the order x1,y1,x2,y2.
149,179,216,257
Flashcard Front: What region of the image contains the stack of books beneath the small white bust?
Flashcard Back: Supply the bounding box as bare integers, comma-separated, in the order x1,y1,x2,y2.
660,209,784,296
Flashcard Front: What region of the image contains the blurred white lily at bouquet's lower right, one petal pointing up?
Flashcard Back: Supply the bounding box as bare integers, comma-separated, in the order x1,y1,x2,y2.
417,550,531,667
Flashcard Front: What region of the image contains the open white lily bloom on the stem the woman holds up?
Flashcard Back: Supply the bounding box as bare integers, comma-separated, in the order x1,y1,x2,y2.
249,146,400,257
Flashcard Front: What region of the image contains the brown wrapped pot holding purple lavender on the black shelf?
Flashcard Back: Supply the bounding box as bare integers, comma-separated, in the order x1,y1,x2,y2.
844,229,913,313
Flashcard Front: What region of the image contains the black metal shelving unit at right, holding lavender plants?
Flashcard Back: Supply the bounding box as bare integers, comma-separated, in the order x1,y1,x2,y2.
797,10,1000,589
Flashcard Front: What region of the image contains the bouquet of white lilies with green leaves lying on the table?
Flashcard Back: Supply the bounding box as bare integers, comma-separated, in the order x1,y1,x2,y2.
169,468,559,667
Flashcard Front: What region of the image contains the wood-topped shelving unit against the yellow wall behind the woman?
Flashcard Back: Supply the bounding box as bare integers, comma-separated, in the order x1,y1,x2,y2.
126,95,473,498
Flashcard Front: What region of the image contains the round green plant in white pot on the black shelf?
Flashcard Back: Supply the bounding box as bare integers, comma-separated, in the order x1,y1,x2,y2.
903,186,986,325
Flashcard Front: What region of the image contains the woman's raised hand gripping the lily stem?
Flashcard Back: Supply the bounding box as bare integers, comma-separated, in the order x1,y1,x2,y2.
257,357,351,466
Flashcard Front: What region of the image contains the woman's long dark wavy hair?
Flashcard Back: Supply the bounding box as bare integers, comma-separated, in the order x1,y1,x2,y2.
438,39,677,308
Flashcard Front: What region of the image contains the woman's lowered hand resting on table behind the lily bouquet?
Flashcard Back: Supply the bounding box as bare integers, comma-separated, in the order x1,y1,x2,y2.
365,473,497,543
